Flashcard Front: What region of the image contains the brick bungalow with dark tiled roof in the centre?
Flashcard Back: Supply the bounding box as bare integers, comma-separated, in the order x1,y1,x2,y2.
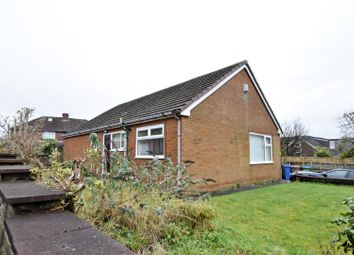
64,61,282,190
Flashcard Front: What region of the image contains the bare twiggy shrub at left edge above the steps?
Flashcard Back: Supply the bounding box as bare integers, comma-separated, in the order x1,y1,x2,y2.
0,107,42,166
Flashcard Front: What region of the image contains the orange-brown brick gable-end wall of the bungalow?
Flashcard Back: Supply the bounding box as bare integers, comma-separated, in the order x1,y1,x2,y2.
182,68,281,189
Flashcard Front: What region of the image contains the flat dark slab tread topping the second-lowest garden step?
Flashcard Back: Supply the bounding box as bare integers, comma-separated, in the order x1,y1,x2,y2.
0,181,65,205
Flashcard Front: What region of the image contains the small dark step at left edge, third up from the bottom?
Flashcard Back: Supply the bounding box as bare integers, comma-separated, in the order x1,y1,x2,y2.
0,165,33,181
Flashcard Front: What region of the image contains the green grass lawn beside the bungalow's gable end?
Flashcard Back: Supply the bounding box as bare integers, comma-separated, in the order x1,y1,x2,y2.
169,183,354,255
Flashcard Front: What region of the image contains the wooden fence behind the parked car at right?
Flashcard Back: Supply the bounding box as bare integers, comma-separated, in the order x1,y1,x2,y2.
281,157,354,171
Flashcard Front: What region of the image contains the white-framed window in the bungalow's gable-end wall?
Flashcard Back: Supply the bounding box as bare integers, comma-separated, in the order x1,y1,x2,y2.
250,133,273,164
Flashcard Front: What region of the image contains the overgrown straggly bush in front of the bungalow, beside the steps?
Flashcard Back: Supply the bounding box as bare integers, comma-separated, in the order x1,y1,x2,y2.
34,135,218,254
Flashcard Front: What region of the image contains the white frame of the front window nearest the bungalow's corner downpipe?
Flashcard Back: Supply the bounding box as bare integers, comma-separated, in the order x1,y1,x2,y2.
135,124,165,159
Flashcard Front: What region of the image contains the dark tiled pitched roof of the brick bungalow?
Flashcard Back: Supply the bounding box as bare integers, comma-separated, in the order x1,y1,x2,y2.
65,61,281,137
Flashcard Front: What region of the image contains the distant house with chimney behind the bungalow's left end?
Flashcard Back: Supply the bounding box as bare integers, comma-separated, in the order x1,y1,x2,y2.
29,113,87,142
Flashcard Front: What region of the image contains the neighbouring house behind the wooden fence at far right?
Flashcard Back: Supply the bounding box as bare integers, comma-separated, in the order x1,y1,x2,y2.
282,136,341,157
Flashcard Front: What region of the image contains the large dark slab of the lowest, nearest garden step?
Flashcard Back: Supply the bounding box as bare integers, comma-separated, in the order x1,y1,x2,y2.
5,211,134,255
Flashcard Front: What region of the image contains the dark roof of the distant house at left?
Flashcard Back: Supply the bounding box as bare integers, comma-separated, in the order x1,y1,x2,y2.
29,116,87,133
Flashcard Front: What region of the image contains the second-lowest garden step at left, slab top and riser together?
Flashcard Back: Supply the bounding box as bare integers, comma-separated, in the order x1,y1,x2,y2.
0,181,65,215
